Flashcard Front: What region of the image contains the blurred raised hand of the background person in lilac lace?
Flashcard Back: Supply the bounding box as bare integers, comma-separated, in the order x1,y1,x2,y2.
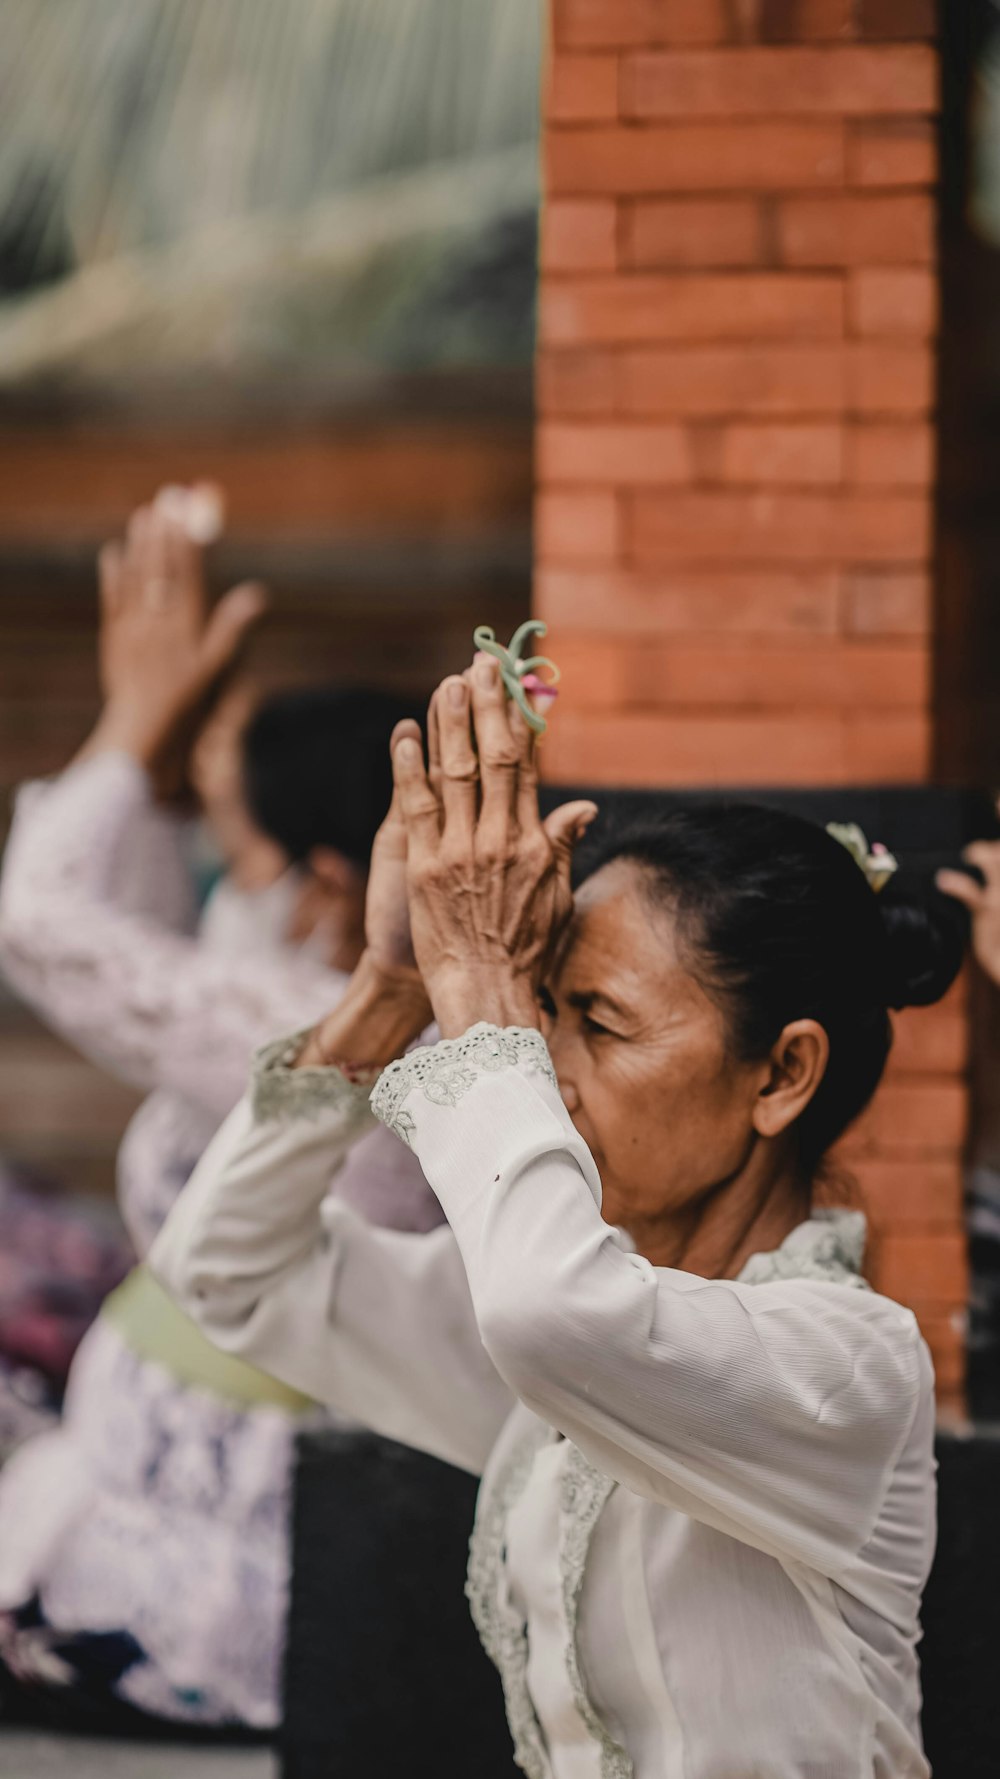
87,489,265,788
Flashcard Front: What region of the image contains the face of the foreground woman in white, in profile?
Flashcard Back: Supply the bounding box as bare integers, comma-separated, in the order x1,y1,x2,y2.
544,859,769,1240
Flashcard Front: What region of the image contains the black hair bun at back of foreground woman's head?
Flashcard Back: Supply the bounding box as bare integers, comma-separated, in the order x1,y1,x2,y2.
879,873,968,1012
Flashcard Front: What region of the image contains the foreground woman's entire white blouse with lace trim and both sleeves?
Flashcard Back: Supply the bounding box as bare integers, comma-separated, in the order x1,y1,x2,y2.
151,1026,934,1779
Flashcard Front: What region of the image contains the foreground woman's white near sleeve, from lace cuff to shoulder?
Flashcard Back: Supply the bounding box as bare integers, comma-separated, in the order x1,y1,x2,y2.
372,1026,920,1574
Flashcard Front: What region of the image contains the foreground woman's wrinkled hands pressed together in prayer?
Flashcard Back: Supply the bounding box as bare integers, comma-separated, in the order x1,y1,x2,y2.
295,656,598,1073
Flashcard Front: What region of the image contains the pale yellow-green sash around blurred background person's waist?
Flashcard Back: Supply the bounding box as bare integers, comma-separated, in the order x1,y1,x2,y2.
101,1267,315,1414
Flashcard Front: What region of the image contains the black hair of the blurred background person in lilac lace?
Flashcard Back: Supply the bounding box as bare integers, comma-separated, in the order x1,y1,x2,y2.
244,685,423,870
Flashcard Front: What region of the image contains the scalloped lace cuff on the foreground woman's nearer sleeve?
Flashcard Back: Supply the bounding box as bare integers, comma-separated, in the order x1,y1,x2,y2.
372,1025,555,1147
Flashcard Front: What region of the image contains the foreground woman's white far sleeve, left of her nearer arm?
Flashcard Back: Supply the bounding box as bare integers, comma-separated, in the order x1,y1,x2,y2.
149,1039,512,1475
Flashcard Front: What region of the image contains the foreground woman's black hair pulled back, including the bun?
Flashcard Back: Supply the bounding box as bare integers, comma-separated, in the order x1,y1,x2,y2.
589,804,966,1176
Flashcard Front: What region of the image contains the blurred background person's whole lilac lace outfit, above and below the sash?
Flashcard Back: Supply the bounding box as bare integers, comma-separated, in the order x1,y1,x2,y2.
0,753,441,1727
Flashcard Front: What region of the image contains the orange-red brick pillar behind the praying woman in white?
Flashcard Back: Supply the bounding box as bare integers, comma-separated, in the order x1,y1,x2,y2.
536,0,966,1388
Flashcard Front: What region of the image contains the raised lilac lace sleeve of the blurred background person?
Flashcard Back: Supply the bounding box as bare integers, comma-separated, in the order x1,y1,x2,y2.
0,753,345,1119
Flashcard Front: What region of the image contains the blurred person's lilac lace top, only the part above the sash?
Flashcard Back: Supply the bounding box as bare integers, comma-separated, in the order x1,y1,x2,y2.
0,753,440,1254
